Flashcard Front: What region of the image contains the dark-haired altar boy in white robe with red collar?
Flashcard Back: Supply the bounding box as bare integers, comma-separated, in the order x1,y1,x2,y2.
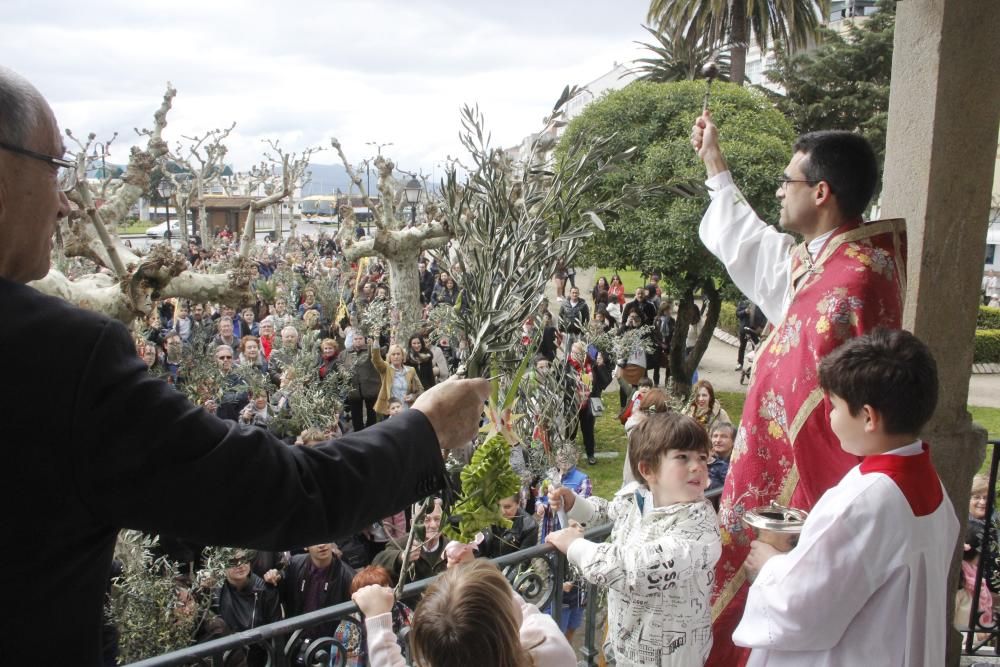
733,329,958,667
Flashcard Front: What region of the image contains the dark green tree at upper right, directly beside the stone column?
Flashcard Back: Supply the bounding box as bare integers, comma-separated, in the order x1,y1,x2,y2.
767,0,896,192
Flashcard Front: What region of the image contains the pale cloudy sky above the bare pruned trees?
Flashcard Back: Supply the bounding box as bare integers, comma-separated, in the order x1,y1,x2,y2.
0,0,648,181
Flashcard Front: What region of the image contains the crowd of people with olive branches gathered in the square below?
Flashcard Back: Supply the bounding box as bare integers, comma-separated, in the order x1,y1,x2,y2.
107,197,764,664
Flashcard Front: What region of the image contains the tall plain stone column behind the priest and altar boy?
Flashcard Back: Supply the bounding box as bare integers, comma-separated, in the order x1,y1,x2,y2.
882,0,1000,665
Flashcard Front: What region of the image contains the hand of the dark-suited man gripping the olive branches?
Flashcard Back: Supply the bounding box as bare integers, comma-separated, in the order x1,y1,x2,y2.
413,378,490,449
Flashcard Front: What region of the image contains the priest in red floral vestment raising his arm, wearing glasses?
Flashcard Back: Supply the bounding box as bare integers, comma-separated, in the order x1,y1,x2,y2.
691,111,906,667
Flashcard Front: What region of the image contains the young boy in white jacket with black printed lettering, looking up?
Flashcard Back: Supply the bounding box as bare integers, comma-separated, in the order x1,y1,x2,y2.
546,413,722,667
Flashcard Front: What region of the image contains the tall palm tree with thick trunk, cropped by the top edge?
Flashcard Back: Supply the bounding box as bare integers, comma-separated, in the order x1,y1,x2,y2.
646,0,830,85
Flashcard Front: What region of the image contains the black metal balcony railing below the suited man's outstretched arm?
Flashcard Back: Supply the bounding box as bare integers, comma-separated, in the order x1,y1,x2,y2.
131,523,612,667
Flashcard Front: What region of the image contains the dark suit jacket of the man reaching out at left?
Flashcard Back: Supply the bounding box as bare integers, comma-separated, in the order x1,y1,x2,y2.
0,279,444,665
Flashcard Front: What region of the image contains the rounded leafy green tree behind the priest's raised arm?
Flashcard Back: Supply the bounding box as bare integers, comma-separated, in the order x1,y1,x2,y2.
557,81,794,393
